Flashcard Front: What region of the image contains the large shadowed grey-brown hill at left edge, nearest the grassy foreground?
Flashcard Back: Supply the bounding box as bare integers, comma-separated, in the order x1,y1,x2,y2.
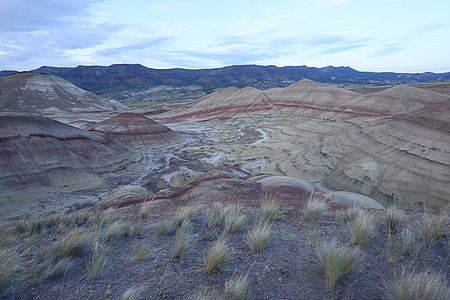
0,116,142,219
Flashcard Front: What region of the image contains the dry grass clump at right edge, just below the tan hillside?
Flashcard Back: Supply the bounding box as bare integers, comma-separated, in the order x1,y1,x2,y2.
413,211,450,244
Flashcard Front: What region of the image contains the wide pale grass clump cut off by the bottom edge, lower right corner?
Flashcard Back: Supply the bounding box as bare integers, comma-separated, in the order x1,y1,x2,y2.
388,270,450,300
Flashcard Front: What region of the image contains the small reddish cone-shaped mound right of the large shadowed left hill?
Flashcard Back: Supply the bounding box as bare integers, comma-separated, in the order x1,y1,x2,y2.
86,112,182,149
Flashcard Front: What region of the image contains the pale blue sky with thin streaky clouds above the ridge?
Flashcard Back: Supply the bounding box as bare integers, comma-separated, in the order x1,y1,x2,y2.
0,0,450,72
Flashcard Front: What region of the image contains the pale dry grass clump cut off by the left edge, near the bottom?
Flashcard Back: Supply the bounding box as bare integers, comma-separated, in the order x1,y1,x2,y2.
0,248,22,293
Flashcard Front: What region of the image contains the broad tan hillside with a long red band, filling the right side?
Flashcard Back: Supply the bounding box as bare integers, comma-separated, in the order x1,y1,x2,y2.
155,80,450,209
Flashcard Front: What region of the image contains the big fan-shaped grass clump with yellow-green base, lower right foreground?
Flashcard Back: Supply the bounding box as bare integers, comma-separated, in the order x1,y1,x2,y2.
315,240,360,290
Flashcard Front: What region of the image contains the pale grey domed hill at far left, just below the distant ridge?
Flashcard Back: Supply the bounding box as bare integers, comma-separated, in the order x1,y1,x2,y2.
0,72,125,113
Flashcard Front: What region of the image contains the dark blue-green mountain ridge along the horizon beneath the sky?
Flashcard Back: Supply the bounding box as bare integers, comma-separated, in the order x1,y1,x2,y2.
0,64,450,101
